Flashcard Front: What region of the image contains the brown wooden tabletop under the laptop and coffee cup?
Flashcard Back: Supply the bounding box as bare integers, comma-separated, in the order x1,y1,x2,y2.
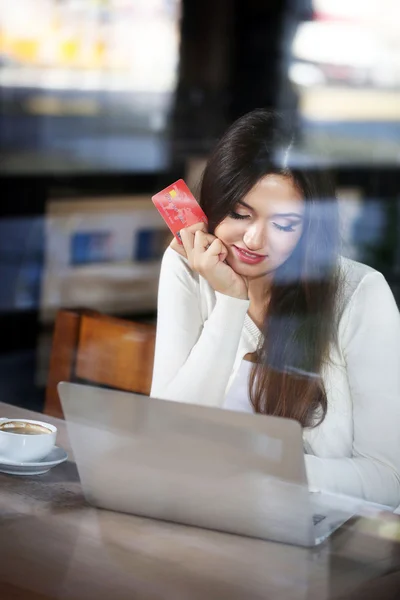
0,403,400,600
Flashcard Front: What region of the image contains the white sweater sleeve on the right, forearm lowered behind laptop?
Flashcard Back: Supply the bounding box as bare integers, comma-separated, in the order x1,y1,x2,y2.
306,272,400,507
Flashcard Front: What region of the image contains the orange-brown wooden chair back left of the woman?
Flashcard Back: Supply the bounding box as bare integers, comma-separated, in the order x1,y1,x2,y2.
44,310,155,417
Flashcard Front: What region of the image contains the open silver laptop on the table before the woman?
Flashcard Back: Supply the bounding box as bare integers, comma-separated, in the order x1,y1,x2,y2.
58,382,384,546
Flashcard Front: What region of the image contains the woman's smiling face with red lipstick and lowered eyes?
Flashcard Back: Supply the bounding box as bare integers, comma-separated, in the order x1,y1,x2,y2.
215,175,305,278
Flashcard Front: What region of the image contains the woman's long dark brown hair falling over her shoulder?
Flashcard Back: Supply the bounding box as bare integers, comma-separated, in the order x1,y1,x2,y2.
200,109,339,427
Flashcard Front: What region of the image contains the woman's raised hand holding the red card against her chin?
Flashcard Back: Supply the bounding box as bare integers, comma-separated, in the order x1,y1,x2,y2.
171,223,248,300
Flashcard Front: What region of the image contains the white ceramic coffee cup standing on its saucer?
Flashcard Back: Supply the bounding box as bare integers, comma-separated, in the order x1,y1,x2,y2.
0,419,57,462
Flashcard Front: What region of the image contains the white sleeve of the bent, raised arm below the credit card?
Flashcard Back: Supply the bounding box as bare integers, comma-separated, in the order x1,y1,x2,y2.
151,248,249,406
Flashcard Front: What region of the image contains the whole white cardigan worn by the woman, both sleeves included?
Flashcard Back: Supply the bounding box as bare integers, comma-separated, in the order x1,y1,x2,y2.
151,248,400,507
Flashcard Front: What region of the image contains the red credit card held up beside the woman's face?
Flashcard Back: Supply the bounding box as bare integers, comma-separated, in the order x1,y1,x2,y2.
152,179,208,244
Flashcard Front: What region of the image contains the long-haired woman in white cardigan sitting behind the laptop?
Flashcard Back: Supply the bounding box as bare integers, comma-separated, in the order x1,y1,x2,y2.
151,110,400,507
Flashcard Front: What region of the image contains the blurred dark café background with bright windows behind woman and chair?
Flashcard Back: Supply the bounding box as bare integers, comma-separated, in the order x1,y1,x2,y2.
0,0,400,410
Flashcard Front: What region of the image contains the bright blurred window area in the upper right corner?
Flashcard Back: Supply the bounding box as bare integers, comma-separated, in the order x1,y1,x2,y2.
289,0,400,163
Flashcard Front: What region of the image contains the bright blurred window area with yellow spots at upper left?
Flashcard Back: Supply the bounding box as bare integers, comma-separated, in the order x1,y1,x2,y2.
0,0,179,171
